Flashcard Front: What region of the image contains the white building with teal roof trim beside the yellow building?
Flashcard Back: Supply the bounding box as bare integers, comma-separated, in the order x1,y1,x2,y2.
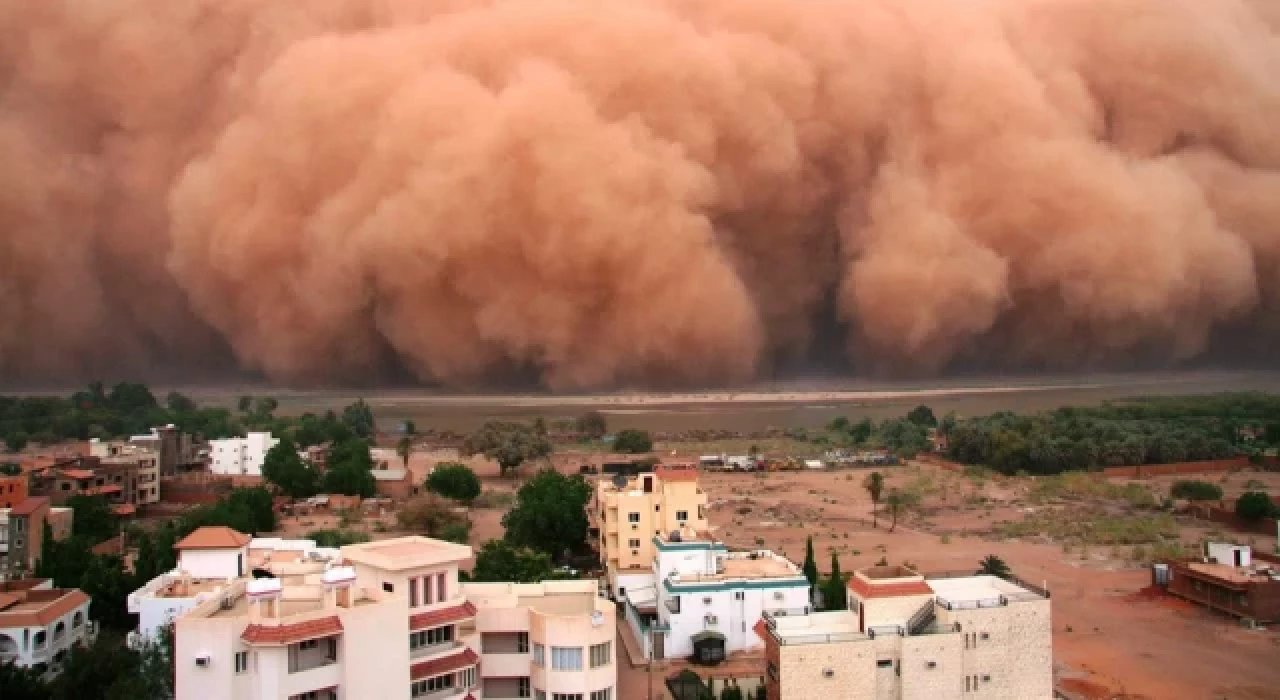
626,531,809,663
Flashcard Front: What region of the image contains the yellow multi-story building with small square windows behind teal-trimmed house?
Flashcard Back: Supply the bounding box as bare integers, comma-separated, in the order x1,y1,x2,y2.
591,466,707,600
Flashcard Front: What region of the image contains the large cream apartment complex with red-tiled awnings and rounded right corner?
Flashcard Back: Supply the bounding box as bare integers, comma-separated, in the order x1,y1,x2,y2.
174,537,617,700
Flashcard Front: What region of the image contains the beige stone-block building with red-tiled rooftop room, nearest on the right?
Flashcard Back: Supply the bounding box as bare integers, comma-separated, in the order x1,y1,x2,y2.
758,566,1053,700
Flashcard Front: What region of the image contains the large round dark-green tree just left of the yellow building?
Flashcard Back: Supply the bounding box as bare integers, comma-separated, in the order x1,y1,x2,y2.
502,470,591,558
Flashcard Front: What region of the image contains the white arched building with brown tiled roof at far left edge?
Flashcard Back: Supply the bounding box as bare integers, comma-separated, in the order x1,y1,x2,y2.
0,578,93,672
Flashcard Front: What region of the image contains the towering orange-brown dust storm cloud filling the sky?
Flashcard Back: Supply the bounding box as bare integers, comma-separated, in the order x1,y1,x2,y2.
0,0,1280,389
